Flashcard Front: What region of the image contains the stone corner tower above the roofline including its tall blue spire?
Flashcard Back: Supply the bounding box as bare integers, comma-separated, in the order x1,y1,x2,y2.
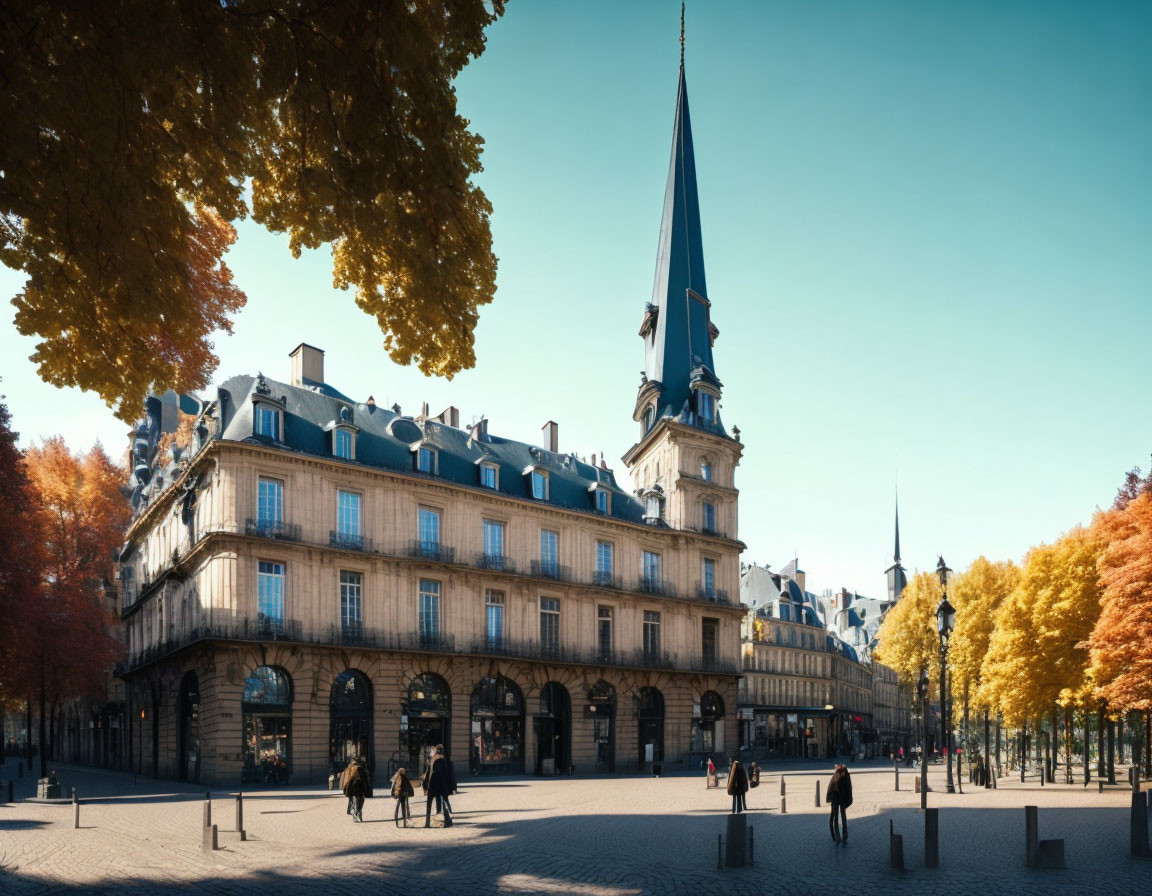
623,32,743,536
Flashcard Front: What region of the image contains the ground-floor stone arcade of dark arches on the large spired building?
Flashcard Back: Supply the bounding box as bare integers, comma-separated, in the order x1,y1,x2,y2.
126,643,737,787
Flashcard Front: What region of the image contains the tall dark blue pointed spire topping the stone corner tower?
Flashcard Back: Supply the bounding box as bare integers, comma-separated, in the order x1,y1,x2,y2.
637,15,722,432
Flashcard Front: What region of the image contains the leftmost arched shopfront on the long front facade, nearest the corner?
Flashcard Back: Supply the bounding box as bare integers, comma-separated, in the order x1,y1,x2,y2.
241,666,291,784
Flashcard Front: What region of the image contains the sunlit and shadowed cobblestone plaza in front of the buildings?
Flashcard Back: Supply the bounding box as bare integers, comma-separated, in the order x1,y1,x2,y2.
0,759,1152,896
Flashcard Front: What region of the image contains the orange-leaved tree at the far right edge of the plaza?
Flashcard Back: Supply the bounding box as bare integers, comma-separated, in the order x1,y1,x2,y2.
1089,493,1152,711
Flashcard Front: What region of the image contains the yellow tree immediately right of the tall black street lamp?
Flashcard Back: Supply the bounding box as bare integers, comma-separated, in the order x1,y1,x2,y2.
948,556,1020,731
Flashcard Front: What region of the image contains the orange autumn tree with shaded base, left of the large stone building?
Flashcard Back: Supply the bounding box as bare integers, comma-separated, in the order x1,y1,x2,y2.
18,438,129,776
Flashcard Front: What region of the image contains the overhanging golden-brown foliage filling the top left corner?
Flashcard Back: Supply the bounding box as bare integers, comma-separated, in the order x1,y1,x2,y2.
0,0,503,420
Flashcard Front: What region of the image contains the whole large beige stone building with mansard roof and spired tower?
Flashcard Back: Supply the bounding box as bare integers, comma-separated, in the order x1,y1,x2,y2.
114,48,744,785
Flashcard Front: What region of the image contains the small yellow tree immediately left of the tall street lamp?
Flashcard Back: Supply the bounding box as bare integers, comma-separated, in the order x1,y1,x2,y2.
874,572,941,693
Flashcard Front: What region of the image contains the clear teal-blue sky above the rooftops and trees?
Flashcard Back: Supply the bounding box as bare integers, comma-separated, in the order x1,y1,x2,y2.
0,0,1152,594
